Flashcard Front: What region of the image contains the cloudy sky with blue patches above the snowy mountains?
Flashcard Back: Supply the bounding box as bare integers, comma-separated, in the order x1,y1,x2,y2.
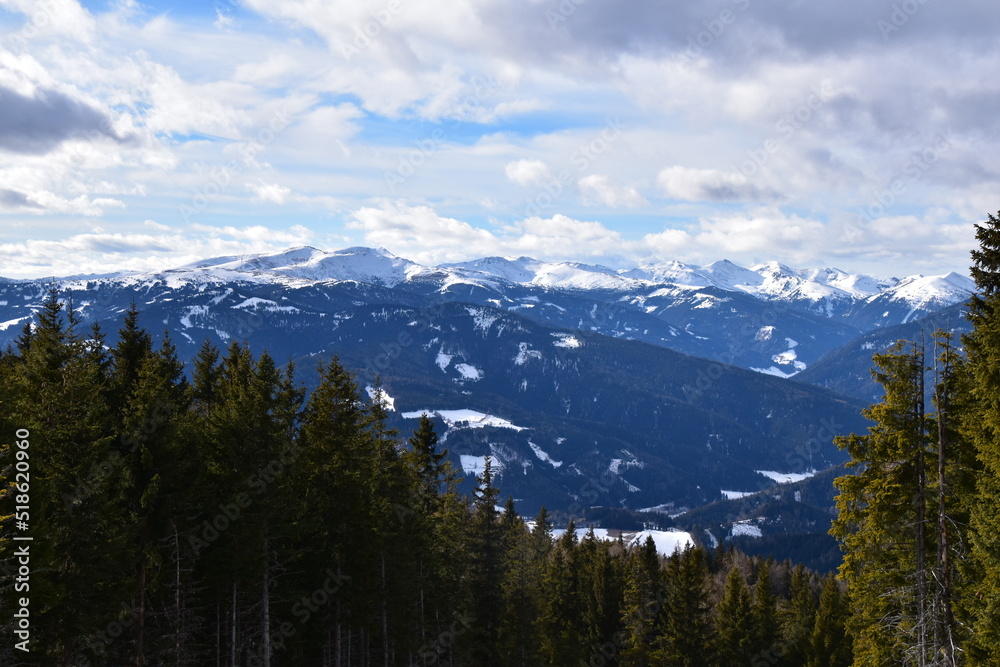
0,0,1000,278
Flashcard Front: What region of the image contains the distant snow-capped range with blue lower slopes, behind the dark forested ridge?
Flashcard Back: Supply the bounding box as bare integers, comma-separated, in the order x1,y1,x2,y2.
0,247,974,384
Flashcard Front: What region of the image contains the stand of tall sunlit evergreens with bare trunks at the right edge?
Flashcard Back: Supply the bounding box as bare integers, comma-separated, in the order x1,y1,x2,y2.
831,215,1000,667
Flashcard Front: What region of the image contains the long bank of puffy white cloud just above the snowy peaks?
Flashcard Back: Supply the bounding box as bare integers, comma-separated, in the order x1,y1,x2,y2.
348,202,970,276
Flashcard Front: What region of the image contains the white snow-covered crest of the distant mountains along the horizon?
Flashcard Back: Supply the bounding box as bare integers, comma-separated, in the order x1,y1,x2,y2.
52,246,975,317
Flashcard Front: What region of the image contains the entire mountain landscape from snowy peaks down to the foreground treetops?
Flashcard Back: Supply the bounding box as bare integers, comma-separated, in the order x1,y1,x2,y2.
0,247,974,556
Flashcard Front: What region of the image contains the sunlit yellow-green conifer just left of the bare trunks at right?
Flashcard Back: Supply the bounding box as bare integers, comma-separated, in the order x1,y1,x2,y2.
831,344,928,666
